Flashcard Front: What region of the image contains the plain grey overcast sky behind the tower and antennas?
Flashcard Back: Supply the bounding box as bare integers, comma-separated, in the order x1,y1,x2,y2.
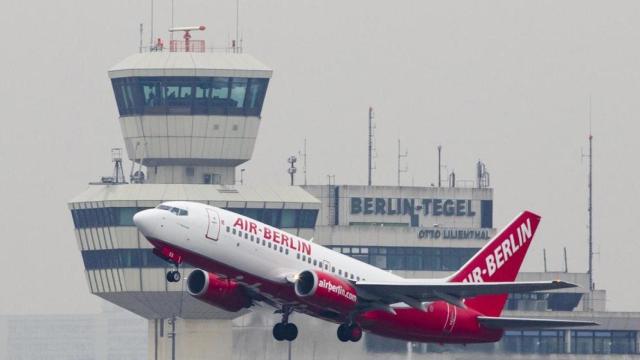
0,0,640,314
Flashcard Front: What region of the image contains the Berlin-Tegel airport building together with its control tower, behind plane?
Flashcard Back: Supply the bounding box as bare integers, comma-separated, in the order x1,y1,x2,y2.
57,28,640,359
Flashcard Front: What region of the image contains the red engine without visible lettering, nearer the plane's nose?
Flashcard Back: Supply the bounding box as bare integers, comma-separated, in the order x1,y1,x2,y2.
187,269,251,312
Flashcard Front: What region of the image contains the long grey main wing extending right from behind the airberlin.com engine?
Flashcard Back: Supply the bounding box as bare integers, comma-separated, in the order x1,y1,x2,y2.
356,280,577,310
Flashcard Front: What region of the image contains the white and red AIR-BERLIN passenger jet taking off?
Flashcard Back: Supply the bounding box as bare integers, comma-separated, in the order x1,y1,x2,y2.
133,201,598,344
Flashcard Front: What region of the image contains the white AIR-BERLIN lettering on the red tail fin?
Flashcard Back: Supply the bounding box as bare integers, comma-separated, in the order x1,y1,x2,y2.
462,219,533,283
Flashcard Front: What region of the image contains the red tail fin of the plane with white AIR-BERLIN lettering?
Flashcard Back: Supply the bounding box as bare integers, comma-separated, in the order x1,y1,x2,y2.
449,211,540,316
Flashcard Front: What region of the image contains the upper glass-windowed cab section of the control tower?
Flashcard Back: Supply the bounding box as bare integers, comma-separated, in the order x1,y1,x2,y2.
109,45,272,184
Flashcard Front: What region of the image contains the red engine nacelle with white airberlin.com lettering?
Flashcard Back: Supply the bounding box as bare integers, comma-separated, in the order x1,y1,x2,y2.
295,270,358,313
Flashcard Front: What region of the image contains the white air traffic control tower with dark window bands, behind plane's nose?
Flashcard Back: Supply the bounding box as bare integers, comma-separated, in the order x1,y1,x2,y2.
69,27,320,359
